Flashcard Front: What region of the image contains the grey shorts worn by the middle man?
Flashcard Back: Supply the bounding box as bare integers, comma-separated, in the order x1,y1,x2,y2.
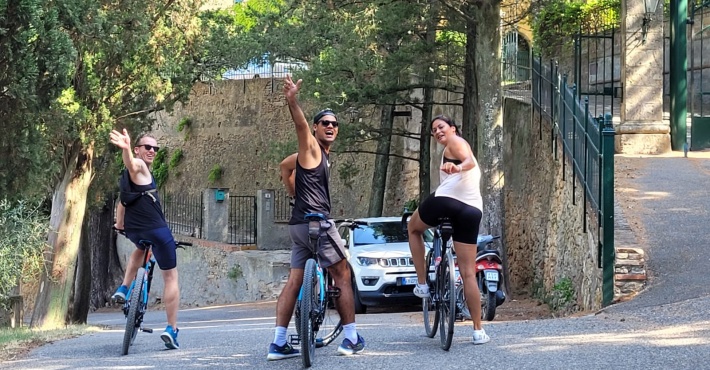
288,220,346,269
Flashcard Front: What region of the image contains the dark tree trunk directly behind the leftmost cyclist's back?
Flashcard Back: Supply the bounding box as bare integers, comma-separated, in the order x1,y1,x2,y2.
86,194,124,310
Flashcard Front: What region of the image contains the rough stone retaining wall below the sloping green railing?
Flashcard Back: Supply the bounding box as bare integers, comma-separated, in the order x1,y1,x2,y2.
503,99,602,310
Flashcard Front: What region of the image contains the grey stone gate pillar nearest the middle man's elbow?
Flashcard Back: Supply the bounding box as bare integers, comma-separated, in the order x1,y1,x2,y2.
256,189,291,250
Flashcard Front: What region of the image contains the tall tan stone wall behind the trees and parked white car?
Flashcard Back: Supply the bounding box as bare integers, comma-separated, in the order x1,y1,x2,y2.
152,78,418,217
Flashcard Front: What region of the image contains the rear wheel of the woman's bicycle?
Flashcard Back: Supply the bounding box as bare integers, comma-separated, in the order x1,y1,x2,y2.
438,250,456,351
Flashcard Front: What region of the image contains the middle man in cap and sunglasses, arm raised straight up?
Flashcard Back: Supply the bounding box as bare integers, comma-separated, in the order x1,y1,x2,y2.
267,76,365,360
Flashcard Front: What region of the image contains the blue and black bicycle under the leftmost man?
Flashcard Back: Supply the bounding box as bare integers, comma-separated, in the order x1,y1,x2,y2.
114,229,192,355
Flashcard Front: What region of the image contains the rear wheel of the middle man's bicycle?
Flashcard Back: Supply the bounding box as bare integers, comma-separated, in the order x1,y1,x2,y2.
298,259,318,367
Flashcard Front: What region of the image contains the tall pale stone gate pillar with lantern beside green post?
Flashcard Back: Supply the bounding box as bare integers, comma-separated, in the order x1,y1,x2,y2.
615,0,671,154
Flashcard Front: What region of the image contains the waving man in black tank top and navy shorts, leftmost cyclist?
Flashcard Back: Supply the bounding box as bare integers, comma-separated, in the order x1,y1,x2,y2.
110,129,180,349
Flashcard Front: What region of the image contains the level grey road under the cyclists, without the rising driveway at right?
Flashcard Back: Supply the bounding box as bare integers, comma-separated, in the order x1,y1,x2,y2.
0,297,710,370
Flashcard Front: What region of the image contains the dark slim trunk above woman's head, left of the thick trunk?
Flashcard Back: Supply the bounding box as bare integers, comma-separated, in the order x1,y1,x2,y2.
461,6,481,158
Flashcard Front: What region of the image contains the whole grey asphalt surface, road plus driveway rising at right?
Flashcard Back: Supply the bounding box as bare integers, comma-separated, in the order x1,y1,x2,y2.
5,155,710,370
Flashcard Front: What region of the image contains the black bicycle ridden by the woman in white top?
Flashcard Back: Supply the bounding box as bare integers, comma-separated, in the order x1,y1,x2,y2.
402,212,456,351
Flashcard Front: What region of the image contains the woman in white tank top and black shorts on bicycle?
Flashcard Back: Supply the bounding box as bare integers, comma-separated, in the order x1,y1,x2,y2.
407,115,490,344
